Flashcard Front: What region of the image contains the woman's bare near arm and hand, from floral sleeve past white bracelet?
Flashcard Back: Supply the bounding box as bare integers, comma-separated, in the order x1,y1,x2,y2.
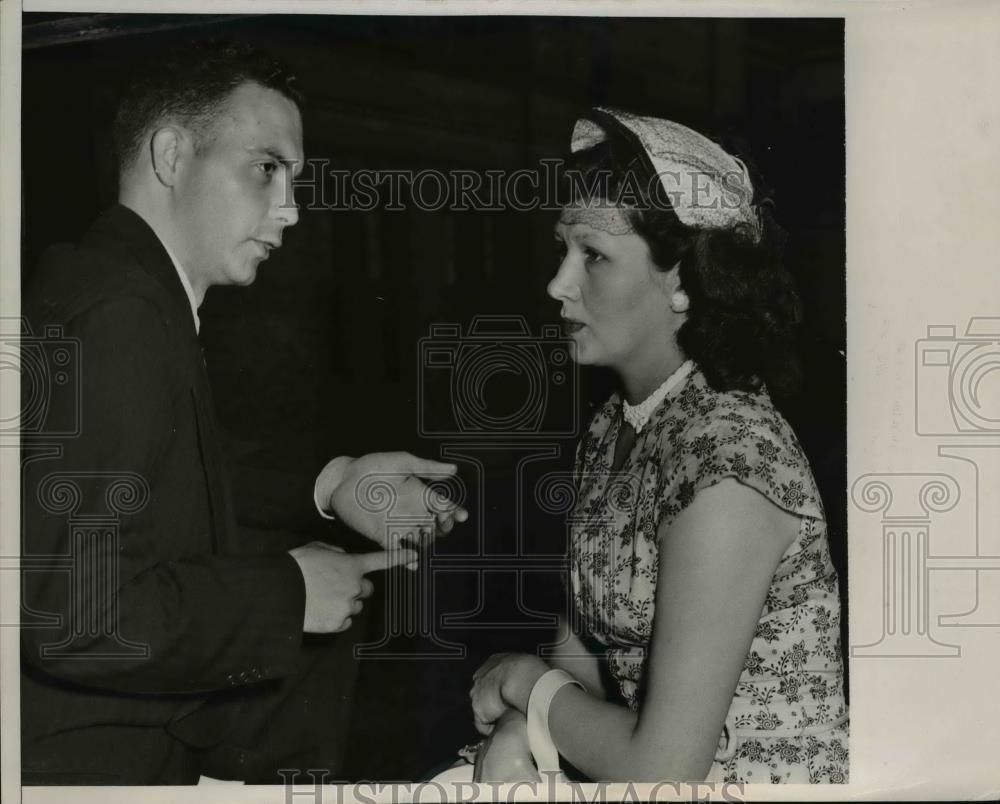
474,479,799,781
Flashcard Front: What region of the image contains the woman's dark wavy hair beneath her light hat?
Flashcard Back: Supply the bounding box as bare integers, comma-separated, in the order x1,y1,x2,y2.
564,125,801,396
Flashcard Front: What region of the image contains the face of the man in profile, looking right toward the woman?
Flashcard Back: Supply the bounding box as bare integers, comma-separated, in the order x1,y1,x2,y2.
173,83,303,288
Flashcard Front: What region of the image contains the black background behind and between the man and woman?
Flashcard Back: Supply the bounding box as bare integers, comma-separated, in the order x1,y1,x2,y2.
22,14,847,779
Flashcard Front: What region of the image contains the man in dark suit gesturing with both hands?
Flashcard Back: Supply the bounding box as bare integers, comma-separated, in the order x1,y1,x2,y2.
22,39,466,784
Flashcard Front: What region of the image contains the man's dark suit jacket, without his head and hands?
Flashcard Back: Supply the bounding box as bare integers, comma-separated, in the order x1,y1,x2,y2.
21,206,311,783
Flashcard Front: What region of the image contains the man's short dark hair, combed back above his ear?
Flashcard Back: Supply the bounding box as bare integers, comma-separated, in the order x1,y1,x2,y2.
112,40,302,173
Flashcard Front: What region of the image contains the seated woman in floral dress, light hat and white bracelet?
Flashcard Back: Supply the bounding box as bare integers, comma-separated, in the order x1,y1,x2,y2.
471,109,848,783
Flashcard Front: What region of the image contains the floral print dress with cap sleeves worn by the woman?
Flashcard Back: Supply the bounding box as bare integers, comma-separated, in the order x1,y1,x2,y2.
570,367,848,784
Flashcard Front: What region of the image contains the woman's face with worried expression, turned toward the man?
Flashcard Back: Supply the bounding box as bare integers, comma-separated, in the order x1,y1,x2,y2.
548,201,680,374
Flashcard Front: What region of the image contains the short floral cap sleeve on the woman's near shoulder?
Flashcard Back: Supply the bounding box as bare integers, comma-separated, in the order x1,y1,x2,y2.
660,405,824,522
